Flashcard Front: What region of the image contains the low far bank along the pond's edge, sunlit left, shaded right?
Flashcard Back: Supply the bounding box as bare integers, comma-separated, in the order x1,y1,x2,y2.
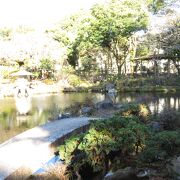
0,81,180,98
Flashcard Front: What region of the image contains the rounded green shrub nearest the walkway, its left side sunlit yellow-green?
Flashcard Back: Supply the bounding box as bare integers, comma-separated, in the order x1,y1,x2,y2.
60,116,149,176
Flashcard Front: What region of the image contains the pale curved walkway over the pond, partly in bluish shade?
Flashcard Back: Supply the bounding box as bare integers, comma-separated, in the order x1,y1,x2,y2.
0,117,93,180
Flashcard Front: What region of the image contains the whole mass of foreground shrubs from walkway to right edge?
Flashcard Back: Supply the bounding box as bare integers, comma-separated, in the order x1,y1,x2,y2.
59,104,180,178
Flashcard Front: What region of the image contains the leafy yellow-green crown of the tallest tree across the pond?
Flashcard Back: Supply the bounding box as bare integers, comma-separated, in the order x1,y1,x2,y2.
90,0,147,47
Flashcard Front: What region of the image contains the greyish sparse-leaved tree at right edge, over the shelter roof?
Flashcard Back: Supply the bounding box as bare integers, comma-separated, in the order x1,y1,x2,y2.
141,14,180,74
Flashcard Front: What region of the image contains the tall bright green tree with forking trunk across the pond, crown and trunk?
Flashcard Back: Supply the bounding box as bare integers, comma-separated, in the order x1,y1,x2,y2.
79,0,148,74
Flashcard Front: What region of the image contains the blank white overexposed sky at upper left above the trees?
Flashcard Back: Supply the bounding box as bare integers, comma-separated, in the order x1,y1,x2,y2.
0,0,105,28
